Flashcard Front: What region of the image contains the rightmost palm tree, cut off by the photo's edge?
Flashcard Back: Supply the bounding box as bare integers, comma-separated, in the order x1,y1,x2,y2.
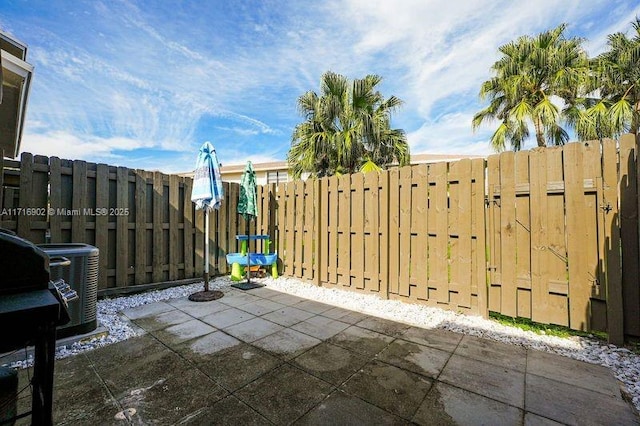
573,17,640,139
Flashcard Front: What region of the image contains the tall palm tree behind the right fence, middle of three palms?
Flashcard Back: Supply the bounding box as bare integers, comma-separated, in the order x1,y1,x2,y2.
472,24,588,151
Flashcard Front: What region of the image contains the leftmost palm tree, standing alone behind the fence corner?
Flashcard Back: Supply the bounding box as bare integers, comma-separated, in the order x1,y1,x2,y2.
287,71,410,178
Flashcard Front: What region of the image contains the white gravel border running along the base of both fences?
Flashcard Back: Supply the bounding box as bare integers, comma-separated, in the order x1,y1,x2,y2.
5,276,640,410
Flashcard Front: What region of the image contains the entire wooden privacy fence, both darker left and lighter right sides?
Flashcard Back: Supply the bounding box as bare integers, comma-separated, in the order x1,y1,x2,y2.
0,135,640,342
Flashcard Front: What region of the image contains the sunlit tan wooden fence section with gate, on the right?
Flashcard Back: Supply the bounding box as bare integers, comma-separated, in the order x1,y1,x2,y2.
263,135,640,342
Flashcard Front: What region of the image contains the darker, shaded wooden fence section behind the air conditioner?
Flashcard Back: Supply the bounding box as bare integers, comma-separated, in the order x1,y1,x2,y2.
0,153,246,294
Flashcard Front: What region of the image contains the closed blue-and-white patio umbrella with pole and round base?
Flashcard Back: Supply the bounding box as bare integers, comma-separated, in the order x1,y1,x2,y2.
189,142,224,302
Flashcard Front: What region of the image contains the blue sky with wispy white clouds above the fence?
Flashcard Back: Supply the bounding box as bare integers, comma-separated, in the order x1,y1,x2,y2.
0,0,640,173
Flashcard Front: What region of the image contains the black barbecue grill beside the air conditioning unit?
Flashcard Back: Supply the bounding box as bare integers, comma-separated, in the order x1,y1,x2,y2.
0,229,77,425
